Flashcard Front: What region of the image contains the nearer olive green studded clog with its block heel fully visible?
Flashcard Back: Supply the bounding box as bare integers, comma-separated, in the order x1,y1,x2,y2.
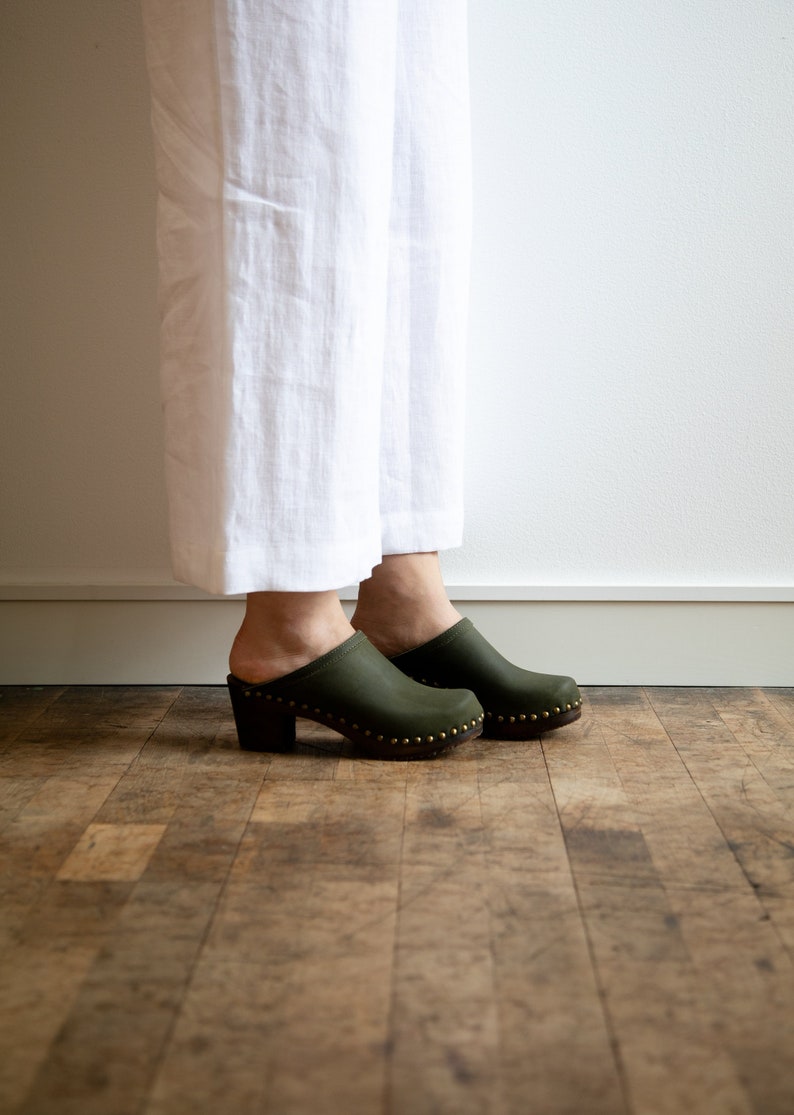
226,631,484,759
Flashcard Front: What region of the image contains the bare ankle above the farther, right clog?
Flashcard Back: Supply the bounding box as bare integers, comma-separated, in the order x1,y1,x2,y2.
352,553,461,658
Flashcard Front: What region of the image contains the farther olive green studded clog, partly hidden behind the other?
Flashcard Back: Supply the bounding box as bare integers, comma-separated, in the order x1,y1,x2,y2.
390,619,582,739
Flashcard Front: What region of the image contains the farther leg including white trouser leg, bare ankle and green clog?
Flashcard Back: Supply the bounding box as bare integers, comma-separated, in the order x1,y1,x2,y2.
354,0,581,739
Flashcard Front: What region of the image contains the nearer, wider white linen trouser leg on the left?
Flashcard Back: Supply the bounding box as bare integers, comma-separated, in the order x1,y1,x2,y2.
144,0,397,593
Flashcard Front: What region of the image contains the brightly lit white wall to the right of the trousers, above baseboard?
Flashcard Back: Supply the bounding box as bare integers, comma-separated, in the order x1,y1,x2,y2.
448,0,794,585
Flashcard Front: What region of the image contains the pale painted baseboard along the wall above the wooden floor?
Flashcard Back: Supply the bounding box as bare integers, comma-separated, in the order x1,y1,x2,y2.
0,584,794,686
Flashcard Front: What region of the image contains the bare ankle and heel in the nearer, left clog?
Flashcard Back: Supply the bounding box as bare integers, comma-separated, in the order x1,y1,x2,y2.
229,592,355,682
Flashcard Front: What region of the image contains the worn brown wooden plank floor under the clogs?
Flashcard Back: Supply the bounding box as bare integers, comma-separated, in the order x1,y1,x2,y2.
0,687,794,1115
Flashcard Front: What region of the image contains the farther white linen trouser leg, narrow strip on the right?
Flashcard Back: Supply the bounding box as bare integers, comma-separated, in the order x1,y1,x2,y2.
379,0,472,555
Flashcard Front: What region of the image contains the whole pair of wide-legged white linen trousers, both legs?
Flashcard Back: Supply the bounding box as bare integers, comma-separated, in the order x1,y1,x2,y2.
144,0,471,593
